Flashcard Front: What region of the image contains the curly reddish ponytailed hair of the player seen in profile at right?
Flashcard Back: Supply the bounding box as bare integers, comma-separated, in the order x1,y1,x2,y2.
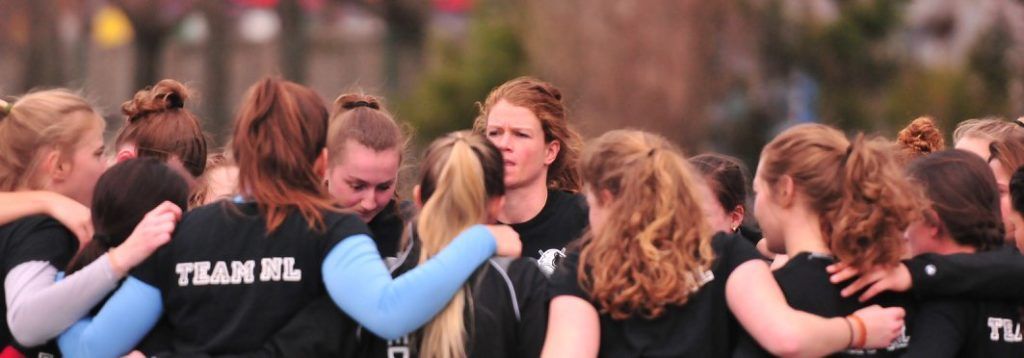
760,124,926,272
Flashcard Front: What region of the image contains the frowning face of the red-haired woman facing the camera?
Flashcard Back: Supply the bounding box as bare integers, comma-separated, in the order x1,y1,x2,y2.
484,99,560,189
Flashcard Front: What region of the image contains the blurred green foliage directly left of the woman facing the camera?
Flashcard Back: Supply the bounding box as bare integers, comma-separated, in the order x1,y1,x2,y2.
397,1,527,143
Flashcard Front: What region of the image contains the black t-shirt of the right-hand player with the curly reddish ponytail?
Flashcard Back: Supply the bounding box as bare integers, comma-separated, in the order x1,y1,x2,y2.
736,253,914,357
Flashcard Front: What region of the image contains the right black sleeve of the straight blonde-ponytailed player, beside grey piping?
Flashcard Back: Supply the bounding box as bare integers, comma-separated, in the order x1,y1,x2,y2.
509,258,550,357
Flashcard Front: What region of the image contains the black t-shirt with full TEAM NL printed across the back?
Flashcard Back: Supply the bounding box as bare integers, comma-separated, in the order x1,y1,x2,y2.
132,202,369,354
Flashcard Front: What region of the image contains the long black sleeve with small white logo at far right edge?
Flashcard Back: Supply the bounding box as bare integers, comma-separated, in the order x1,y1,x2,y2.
903,248,1024,302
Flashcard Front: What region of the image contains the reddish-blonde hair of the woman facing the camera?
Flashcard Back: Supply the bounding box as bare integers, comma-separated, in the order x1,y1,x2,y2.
473,77,583,192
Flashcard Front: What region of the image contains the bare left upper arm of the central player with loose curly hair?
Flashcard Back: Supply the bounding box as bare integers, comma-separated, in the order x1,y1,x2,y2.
541,296,601,357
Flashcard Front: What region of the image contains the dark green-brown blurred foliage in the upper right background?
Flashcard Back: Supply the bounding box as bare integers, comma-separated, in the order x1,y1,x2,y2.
759,0,1013,135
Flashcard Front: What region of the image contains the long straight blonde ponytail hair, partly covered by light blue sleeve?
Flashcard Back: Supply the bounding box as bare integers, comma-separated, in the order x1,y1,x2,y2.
416,132,505,358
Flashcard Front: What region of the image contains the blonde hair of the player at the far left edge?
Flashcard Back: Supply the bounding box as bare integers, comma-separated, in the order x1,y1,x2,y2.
0,89,105,191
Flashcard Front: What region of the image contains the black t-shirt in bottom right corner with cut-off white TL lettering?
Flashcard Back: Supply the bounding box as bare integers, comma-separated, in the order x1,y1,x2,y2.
905,300,1024,358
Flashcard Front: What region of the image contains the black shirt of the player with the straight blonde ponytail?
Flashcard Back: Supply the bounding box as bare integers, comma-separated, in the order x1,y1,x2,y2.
361,237,549,358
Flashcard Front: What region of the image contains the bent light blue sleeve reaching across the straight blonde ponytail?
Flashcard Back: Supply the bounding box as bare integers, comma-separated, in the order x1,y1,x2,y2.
323,225,497,340
